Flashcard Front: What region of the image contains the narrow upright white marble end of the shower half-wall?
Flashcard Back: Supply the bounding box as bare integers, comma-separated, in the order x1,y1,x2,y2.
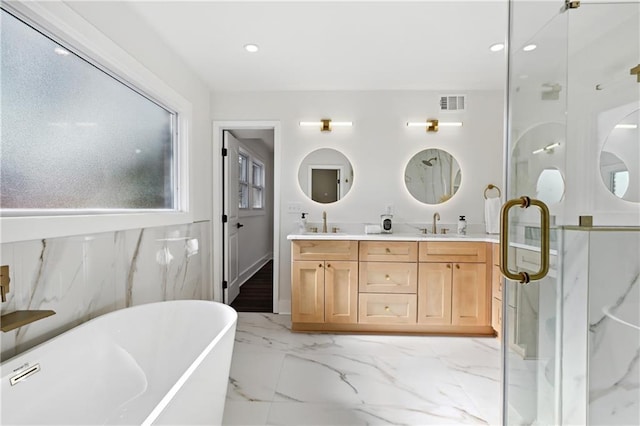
560,230,589,425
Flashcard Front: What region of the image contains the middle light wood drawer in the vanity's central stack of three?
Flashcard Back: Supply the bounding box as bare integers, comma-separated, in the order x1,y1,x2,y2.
358,262,418,294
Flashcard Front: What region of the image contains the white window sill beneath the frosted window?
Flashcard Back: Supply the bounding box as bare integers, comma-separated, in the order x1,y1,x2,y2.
0,212,193,243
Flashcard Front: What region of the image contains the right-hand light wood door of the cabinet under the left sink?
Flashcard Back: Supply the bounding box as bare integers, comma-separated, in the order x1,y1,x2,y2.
324,261,358,324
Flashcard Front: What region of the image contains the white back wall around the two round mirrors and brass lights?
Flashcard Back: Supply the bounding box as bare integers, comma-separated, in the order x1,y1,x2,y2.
211,91,503,312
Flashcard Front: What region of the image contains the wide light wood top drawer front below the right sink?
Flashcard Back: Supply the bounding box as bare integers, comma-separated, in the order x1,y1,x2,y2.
418,241,488,263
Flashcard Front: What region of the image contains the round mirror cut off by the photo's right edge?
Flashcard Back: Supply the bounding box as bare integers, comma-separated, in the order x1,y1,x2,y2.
600,110,640,202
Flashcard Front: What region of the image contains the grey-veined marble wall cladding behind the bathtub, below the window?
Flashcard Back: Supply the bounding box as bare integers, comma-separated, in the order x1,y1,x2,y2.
0,222,213,360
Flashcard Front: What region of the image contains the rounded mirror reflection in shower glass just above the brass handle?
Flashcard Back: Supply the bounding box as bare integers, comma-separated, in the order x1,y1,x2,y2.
511,122,565,205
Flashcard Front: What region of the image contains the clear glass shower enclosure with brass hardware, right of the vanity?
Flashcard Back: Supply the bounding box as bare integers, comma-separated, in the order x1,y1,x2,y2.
502,0,640,425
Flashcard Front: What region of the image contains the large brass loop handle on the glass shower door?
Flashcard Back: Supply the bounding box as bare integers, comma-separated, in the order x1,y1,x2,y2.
500,196,550,284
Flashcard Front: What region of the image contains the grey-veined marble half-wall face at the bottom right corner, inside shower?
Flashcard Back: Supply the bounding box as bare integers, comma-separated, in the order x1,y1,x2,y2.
588,232,640,425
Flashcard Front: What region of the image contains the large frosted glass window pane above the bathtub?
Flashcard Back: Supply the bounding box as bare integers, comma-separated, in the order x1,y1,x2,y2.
0,10,177,210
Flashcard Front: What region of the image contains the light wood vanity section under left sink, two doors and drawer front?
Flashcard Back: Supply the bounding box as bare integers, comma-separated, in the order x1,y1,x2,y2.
291,241,358,324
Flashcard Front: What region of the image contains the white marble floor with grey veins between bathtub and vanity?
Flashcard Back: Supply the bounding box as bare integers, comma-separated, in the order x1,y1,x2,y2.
223,313,500,425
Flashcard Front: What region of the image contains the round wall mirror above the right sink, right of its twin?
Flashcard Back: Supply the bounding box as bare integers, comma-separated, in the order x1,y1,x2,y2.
404,148,462,204
